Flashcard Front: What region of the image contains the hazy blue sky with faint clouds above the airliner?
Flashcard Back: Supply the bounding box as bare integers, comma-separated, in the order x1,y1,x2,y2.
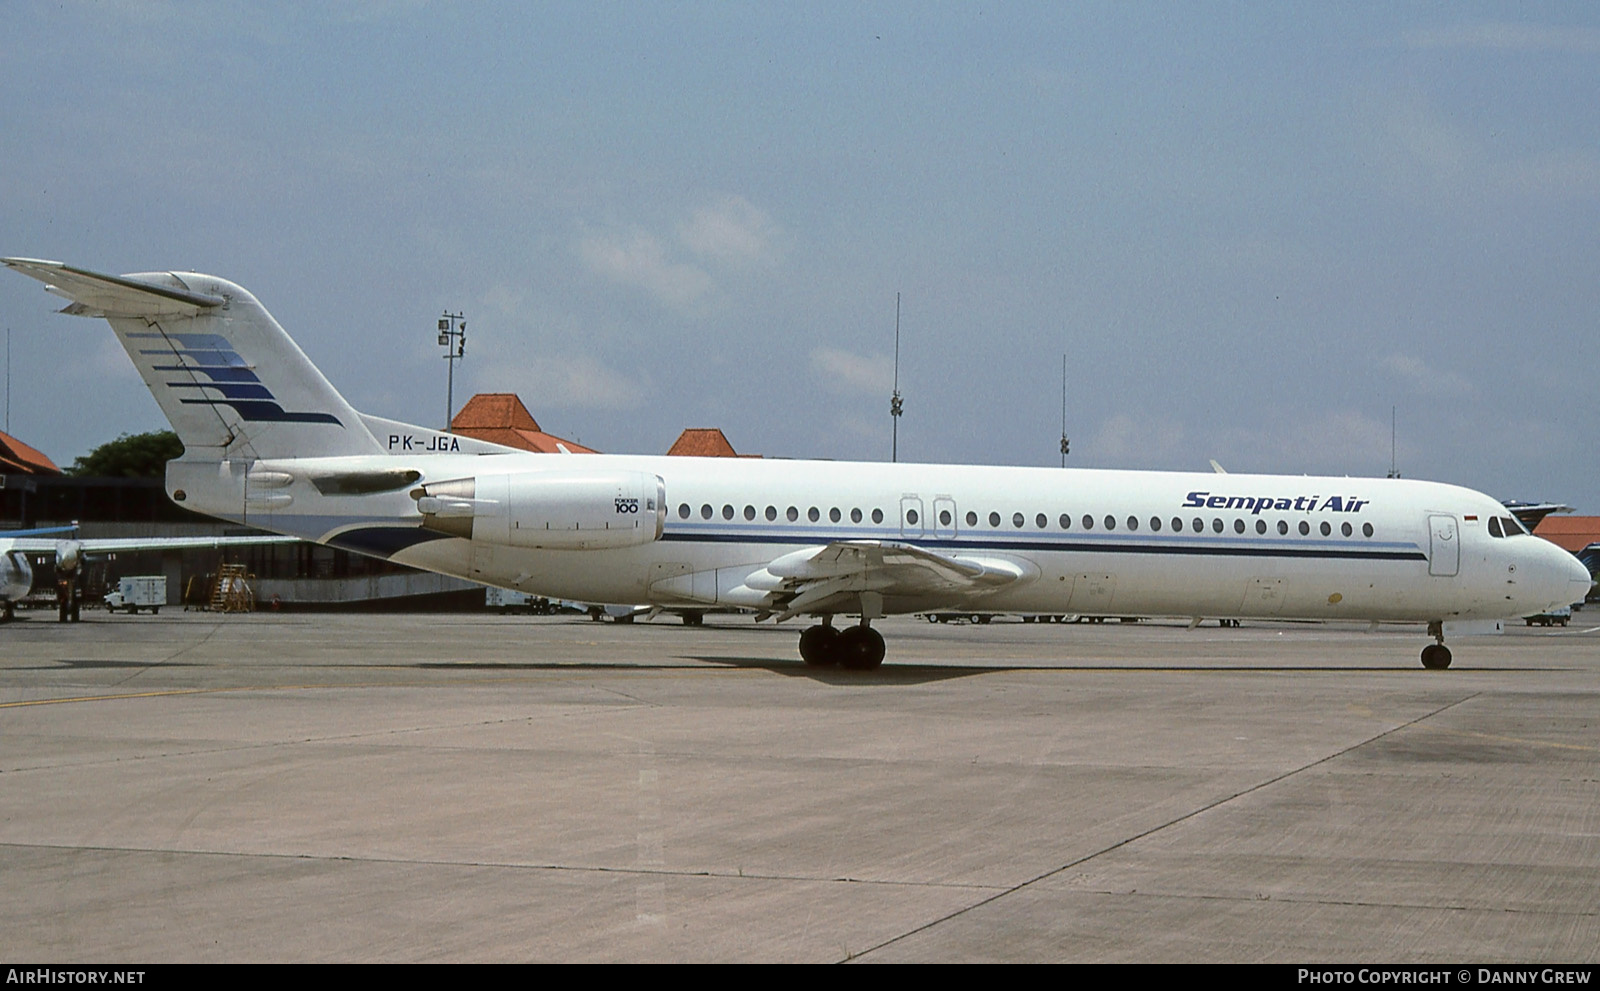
0,0,1600,514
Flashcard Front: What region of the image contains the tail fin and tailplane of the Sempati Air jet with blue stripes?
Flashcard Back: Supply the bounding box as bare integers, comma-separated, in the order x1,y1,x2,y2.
0,258,384,461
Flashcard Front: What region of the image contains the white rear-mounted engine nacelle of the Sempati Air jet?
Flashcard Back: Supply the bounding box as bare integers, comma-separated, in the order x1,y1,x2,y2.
411,469,667,551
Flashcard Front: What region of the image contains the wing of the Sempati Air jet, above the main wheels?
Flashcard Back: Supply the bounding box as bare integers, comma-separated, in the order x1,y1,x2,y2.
746,540,1038,623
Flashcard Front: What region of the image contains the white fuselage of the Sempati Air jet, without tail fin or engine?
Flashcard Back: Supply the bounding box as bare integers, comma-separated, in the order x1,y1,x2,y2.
168,445,1587,621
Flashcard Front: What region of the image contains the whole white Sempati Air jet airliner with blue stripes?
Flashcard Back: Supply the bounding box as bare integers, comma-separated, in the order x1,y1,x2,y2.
5,258,1589,668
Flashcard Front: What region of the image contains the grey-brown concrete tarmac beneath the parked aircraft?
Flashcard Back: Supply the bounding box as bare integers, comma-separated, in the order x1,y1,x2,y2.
0,610,1600,964
